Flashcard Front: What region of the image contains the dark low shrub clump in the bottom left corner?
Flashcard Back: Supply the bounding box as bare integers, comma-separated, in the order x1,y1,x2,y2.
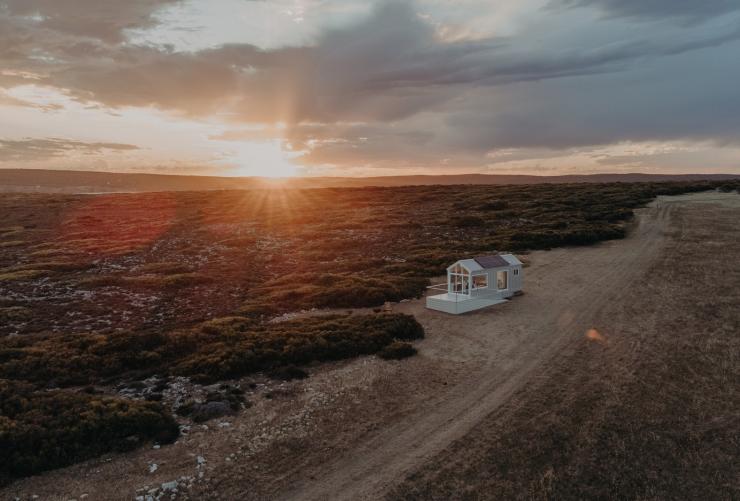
0,379,179,484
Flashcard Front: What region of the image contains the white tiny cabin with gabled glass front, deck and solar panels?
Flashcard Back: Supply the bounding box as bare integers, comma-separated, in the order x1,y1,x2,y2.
427,254,524,314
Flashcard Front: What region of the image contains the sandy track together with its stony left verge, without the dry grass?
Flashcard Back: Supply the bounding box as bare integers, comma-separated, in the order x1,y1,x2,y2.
0,192,740,500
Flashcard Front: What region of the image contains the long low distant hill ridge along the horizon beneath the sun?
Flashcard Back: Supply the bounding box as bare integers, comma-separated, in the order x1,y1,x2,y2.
0,169,740,193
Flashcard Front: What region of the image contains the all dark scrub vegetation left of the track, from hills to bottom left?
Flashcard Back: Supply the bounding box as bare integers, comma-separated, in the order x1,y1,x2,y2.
0,182,737,481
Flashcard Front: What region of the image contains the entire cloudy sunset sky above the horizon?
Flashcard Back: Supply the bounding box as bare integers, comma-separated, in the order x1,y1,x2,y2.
0,0,740,176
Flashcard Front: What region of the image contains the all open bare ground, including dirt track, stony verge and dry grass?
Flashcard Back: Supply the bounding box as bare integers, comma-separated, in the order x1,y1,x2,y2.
0,191,740,499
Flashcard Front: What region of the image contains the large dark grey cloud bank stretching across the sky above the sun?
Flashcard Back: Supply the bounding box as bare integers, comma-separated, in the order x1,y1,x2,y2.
21,2,740,123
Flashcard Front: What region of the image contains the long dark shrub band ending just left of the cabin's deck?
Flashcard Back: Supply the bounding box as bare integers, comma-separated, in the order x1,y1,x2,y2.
0,314,424,386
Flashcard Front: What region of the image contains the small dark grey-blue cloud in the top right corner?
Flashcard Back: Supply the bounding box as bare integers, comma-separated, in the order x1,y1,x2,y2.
553,0,740,23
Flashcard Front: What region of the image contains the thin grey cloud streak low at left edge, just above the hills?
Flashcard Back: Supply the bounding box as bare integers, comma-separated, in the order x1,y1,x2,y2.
0,137,139,162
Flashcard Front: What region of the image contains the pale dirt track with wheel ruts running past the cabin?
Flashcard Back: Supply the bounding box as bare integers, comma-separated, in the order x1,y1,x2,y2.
280,194,737,500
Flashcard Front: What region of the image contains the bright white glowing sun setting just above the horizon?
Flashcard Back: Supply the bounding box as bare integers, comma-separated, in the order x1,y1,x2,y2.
228,140,301,178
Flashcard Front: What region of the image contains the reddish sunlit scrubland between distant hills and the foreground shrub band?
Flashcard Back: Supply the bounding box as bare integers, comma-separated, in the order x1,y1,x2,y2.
0,182,731,335
